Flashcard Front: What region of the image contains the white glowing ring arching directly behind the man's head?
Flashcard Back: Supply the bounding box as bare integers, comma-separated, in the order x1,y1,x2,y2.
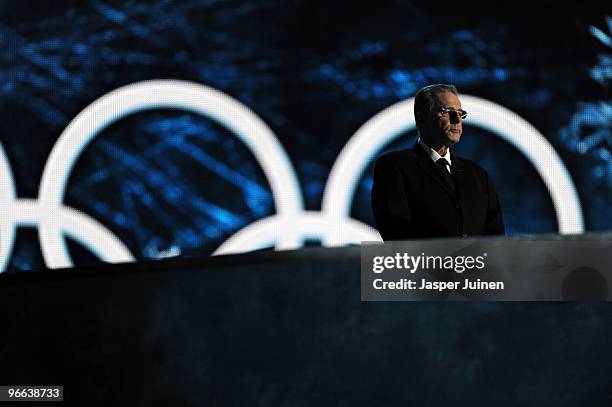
322,95,584,244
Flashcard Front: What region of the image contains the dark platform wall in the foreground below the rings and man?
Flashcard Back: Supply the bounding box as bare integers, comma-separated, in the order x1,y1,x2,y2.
0,247,612,407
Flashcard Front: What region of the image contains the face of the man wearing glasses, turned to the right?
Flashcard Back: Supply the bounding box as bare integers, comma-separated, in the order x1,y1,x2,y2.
419,92,463,147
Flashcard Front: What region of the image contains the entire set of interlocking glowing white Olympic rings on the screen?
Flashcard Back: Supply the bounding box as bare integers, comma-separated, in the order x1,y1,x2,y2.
0,80,584,271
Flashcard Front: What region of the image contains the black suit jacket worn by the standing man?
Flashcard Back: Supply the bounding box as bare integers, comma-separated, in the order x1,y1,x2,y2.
372,143,505,240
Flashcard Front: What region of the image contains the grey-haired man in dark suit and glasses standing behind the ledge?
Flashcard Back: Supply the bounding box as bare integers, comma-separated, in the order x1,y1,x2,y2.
372,84,505,240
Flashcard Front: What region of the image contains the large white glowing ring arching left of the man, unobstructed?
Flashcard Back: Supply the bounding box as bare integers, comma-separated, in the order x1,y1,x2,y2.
38,80,302,268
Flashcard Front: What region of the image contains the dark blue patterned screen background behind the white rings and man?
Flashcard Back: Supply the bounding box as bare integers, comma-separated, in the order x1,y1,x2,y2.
0,0,612,270
